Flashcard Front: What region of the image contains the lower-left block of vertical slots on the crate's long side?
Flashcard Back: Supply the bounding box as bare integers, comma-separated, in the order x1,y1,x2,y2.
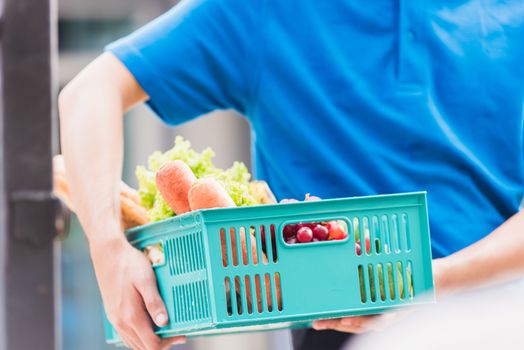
224,273,283,316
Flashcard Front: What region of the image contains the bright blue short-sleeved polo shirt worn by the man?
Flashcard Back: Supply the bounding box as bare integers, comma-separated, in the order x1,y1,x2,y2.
108,0,524,257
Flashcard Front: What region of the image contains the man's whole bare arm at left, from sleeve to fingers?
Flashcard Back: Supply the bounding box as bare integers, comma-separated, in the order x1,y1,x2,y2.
59,53,183,350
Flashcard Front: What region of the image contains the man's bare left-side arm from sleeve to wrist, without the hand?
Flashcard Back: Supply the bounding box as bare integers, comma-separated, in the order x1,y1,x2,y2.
59,52,143,249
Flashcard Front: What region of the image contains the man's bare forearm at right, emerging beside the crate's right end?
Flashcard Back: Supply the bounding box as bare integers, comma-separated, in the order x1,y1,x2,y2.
434,210,524,295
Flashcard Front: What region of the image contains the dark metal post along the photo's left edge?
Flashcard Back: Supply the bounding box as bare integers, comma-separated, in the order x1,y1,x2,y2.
0,0,60,350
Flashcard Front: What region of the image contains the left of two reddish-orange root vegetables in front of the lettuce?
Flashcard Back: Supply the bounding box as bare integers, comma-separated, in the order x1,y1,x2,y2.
156,160,197,215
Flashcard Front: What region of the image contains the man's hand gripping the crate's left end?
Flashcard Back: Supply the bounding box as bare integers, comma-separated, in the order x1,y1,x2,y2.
90,239,185,350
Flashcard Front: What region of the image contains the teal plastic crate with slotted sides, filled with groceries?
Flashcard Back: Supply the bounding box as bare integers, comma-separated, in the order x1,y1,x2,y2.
106,192,434,344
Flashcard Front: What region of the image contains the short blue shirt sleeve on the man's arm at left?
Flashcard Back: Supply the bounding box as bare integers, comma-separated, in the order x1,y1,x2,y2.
106,0,258,124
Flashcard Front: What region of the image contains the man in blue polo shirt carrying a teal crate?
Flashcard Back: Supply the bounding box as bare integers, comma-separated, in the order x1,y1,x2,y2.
60,0,524,349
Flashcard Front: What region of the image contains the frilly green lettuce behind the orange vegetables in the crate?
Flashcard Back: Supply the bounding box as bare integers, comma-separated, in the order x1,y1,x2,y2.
135,136,255,221
